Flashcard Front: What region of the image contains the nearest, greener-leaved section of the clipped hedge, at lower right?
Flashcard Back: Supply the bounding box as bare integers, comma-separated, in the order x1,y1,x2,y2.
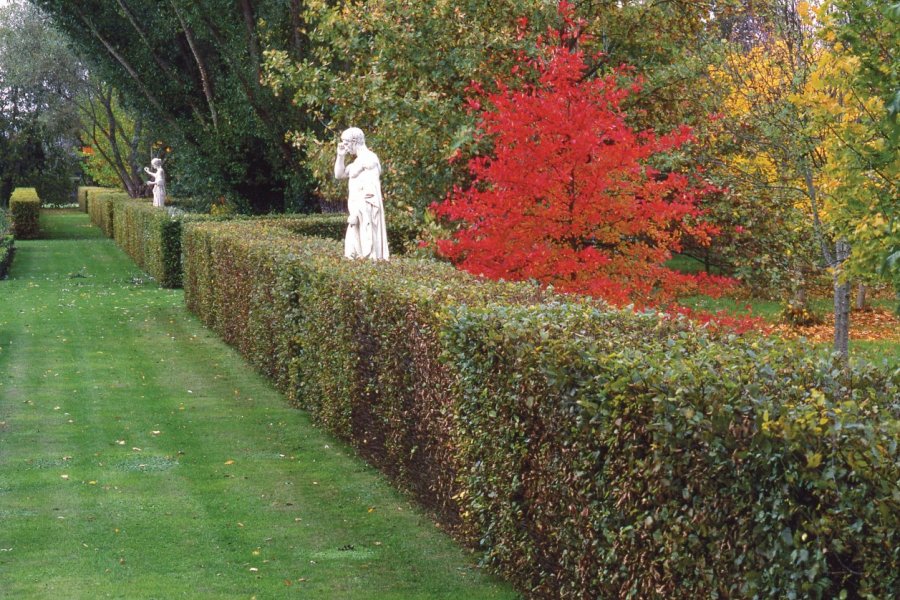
444,305,900,598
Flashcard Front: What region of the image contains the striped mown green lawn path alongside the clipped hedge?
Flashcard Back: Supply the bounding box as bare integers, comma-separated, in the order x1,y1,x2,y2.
0,212,516,599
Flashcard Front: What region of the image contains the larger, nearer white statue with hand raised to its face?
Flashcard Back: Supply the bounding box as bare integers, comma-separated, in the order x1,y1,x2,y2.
334,127,390,260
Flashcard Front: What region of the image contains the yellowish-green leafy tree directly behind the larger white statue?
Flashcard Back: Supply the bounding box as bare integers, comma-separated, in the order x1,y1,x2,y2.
264,0,555,248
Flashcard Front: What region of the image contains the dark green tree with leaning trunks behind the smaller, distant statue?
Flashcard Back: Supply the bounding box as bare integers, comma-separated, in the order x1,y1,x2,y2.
34,0,313,211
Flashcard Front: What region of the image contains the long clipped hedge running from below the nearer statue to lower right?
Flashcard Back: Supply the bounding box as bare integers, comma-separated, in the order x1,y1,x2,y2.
184,223,900,598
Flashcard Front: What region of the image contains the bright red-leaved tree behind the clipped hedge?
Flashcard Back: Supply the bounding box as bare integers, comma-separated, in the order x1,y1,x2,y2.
432,16,730,306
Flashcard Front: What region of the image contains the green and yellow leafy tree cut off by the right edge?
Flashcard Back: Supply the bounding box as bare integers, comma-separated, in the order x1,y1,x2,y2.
796,0,900,304
